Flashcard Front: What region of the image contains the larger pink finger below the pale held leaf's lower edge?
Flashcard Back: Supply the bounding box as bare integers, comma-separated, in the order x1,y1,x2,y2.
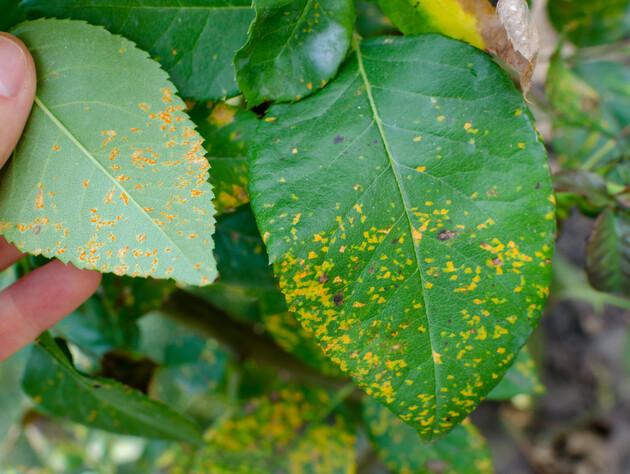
0,260,101,362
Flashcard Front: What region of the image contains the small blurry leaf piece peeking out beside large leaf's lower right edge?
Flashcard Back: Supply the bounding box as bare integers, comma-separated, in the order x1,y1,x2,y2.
487,347,545,400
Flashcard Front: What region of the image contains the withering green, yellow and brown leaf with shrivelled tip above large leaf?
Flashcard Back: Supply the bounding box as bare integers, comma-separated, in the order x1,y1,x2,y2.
379,0,540,94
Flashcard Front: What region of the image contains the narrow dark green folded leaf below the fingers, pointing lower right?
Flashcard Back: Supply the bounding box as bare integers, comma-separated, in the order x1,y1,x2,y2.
23,333,200,444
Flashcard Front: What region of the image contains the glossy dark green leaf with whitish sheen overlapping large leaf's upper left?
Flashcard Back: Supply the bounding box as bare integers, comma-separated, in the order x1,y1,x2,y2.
234,0,355,107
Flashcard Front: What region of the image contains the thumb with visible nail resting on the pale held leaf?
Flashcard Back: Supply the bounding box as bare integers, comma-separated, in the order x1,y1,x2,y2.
0,33,36,167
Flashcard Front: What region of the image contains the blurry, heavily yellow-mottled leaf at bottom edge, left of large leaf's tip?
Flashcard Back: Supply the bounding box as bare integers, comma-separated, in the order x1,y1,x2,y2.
186,386,356,474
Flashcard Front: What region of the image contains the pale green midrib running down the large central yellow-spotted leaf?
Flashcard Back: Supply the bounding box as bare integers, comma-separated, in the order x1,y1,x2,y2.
353,34,439,425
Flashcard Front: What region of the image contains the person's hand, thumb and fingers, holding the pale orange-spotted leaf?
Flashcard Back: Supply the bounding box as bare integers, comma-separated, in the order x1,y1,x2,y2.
0,33,101,362
